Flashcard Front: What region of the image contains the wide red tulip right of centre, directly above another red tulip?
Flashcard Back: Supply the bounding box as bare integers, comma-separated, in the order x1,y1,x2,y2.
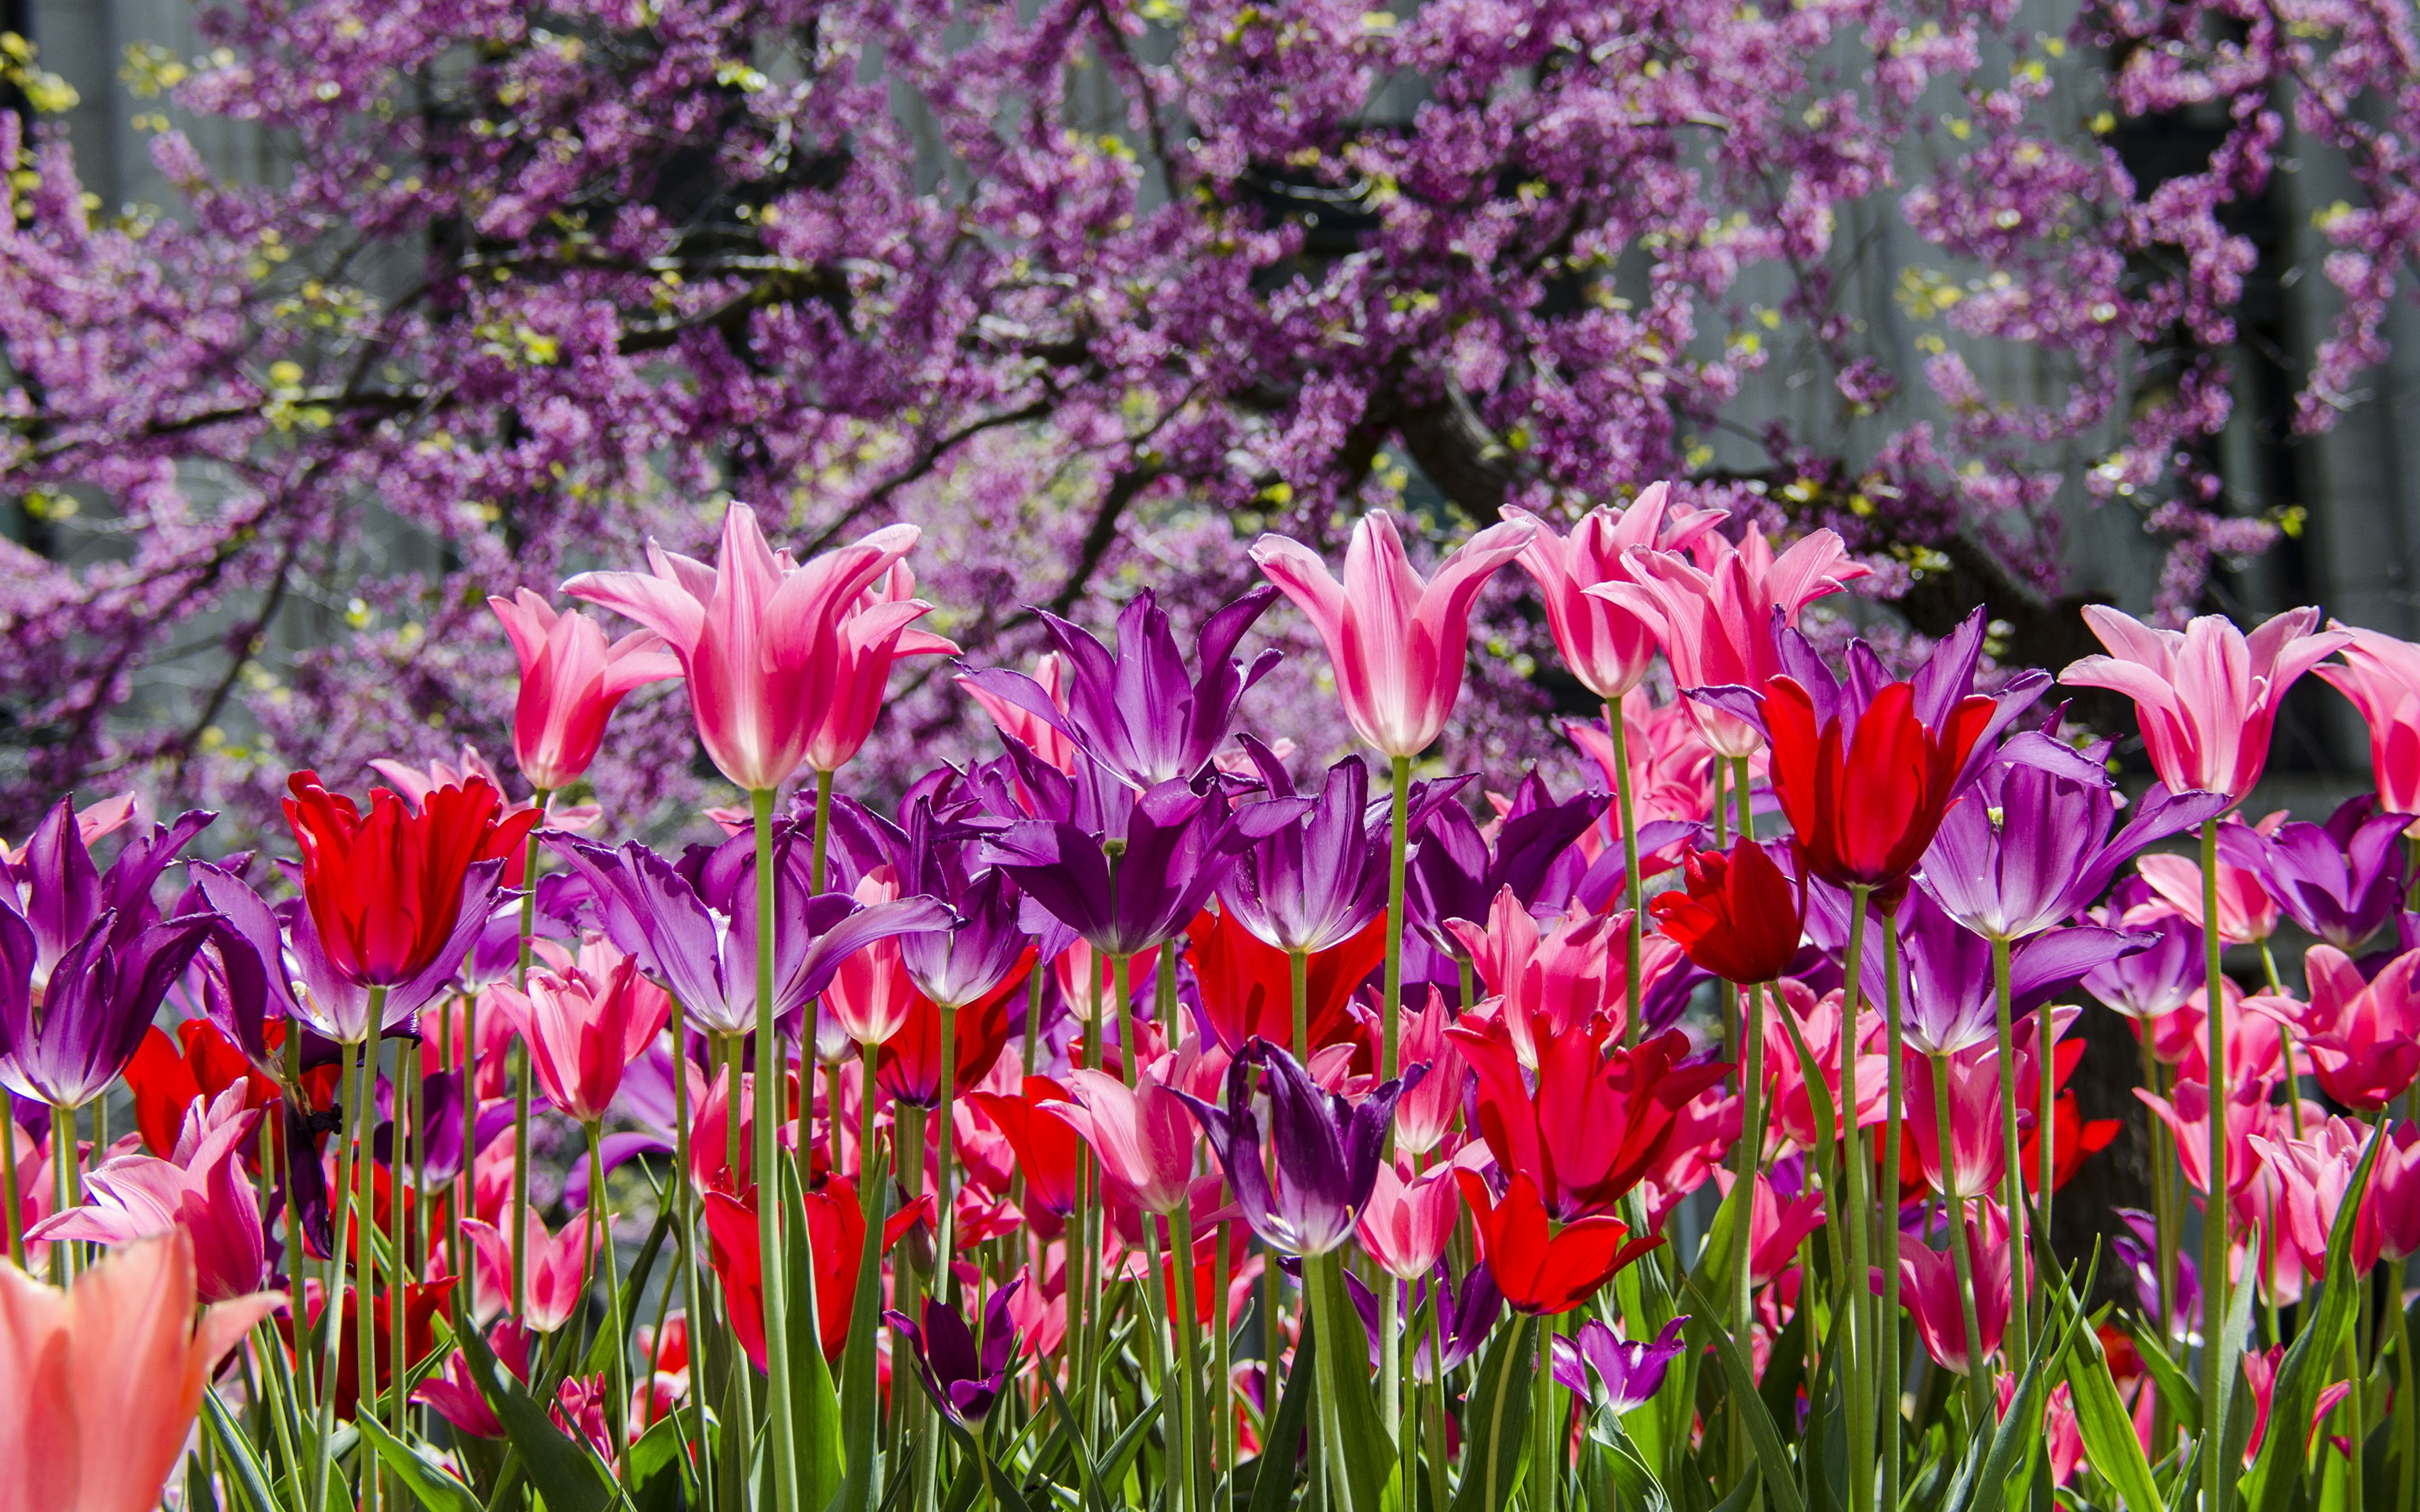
1444,1016,1730,1220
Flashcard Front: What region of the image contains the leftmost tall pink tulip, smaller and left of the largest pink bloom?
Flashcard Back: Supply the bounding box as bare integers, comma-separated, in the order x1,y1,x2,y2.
487,588,680,794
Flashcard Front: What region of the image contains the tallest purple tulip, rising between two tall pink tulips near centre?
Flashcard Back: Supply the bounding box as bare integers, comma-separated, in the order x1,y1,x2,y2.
965,588,1285,791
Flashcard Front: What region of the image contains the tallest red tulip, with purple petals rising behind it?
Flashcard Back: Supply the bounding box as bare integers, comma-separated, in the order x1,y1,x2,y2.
1765,677,1994,902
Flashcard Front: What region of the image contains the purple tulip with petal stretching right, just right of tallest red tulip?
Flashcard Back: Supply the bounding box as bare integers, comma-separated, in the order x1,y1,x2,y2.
1922,731,2228,938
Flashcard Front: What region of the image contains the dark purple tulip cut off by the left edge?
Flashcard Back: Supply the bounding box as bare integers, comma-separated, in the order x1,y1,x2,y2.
0,803,218,1108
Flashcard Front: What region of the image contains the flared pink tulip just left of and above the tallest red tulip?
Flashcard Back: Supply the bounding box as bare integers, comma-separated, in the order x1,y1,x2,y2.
1587,525,1873,757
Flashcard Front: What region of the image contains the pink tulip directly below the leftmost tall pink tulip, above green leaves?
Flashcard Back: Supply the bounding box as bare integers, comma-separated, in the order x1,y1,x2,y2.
489,937,673,1125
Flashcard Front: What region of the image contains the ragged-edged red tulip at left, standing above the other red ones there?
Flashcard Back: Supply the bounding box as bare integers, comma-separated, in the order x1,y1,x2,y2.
286,772,537,987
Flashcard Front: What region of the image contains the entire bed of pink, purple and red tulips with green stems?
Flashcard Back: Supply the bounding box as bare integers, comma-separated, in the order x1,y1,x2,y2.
18,498,2420,1512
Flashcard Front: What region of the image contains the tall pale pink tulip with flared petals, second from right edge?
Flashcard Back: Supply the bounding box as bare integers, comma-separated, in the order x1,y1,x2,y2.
2060,605,2352,801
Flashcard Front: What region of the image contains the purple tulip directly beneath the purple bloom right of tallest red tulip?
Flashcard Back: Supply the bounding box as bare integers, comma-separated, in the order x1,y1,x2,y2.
1861,890,2151,1055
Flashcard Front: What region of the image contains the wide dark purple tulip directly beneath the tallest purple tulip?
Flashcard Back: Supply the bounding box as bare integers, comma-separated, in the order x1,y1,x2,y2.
982,781,1302,956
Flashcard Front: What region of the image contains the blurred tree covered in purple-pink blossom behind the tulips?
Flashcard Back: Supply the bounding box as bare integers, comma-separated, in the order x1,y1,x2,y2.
0,0,2420,832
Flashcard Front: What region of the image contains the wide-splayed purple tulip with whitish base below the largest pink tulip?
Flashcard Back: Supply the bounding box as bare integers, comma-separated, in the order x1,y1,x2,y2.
547,825,951,1036
